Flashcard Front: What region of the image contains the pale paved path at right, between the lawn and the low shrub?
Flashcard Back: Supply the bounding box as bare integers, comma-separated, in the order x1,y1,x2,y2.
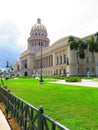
52,79,98,87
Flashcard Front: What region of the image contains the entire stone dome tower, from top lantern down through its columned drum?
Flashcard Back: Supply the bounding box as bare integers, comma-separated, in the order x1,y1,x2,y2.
27,18,50,53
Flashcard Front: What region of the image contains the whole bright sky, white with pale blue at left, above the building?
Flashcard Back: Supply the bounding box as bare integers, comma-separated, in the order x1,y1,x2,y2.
0,0,98,67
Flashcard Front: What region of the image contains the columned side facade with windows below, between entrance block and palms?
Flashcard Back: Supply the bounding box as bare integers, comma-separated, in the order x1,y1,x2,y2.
34,50,67,75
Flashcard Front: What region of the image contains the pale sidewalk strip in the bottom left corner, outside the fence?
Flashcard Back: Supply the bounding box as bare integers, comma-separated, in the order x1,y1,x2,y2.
0,110,11,130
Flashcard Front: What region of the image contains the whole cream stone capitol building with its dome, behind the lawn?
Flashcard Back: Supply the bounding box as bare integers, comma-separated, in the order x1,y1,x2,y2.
14,18,98,76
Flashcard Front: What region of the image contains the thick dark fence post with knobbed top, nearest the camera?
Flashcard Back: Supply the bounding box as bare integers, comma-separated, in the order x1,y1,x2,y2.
38,106,44,130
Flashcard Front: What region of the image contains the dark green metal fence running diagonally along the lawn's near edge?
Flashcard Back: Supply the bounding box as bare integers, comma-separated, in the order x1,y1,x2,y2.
0,87,69,130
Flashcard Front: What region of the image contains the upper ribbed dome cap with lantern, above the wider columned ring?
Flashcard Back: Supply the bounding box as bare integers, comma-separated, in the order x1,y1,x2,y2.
30,18,47,37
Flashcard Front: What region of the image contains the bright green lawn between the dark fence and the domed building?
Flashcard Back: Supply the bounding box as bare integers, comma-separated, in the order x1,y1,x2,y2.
1,78,98,130
